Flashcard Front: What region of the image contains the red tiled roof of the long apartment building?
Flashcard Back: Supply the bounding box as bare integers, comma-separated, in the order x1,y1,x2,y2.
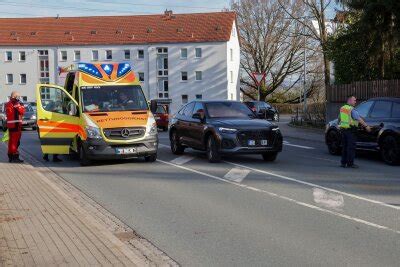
0,12,236,46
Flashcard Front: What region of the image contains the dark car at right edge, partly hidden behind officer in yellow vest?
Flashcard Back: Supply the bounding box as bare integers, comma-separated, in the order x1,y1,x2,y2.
325,98,400,165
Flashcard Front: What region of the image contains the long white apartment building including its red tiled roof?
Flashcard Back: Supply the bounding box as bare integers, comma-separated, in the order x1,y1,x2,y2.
0,11,240,113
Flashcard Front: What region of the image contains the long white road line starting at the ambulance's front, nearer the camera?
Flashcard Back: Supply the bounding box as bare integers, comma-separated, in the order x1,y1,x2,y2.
157,159,400,234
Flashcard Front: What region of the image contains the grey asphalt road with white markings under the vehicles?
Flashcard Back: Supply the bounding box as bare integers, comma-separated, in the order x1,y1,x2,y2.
12,122,400,266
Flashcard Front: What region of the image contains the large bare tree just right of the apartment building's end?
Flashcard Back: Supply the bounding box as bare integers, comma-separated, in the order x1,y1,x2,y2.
231,0,305,100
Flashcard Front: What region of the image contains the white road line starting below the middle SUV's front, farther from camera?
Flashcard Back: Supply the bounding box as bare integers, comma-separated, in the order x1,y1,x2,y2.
224,160,400,210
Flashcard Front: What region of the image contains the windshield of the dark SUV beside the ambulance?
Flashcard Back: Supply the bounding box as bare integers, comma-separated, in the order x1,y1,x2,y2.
205,102,254,118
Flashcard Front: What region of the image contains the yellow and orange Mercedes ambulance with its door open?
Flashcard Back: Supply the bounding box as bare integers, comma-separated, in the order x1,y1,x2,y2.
36,62,158,165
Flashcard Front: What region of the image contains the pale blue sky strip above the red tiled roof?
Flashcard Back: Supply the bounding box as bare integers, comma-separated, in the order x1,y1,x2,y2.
0,0,334,18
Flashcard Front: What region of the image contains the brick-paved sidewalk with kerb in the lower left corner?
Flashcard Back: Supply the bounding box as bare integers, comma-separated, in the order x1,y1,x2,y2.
0,143,177,266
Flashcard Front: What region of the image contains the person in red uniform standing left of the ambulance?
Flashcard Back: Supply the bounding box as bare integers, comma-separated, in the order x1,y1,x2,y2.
5,92,25,163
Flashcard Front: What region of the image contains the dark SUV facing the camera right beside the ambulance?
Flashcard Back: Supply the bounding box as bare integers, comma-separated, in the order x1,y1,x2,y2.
169,101,282,162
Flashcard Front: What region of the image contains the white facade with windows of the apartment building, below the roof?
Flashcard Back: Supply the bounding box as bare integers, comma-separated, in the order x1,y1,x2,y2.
0,13,240,114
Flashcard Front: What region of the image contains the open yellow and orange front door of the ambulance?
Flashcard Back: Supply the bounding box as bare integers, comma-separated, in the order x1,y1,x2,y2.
36,84,85,154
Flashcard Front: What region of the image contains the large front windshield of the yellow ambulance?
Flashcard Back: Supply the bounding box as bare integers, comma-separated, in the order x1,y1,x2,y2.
81,85,148,112
